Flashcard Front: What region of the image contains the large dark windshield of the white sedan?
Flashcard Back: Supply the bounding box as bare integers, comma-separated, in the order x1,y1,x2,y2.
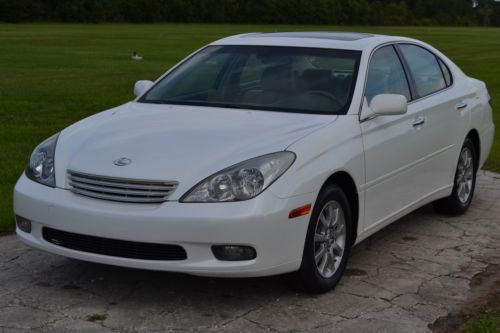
139,45,361,114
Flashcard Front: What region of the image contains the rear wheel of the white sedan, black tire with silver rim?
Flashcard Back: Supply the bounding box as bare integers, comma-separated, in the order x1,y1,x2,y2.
433,138,478,215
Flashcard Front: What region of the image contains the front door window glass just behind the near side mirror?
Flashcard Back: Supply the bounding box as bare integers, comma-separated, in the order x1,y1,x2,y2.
365,46,411,103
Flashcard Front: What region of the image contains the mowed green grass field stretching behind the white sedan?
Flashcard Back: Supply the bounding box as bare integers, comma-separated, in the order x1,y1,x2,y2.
0,24,500,232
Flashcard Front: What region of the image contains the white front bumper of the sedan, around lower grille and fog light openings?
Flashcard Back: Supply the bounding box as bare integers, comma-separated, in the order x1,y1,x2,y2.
14,174,316,277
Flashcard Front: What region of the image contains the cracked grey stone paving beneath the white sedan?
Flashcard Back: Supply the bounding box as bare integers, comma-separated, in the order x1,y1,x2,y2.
0,172,500,332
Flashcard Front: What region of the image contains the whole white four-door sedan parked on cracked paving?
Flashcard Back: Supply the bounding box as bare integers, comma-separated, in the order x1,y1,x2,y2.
14,32,494,292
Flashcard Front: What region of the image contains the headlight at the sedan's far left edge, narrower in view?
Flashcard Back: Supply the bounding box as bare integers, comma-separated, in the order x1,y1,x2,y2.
26,133,59,187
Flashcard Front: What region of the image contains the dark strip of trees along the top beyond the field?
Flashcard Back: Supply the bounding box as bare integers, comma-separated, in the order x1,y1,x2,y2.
0,0,500,26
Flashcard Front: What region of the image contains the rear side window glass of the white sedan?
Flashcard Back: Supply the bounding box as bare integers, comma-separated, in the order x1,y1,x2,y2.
399,44,446,97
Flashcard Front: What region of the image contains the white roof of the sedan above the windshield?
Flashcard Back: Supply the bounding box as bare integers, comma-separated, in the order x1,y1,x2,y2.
211,31,415,51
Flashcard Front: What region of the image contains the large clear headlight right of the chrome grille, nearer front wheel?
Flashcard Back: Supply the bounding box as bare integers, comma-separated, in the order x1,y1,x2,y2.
180,151,295,202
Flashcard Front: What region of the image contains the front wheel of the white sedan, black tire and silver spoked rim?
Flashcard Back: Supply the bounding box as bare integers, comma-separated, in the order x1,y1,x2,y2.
289,185,353,294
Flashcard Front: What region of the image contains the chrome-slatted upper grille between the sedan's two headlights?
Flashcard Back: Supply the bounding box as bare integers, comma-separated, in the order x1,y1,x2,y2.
68,170,178,203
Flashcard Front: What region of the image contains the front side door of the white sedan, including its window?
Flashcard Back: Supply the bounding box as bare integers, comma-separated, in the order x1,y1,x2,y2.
361,45,431,231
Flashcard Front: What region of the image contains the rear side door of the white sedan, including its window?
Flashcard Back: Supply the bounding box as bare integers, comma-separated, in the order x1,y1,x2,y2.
397,43,472,189
